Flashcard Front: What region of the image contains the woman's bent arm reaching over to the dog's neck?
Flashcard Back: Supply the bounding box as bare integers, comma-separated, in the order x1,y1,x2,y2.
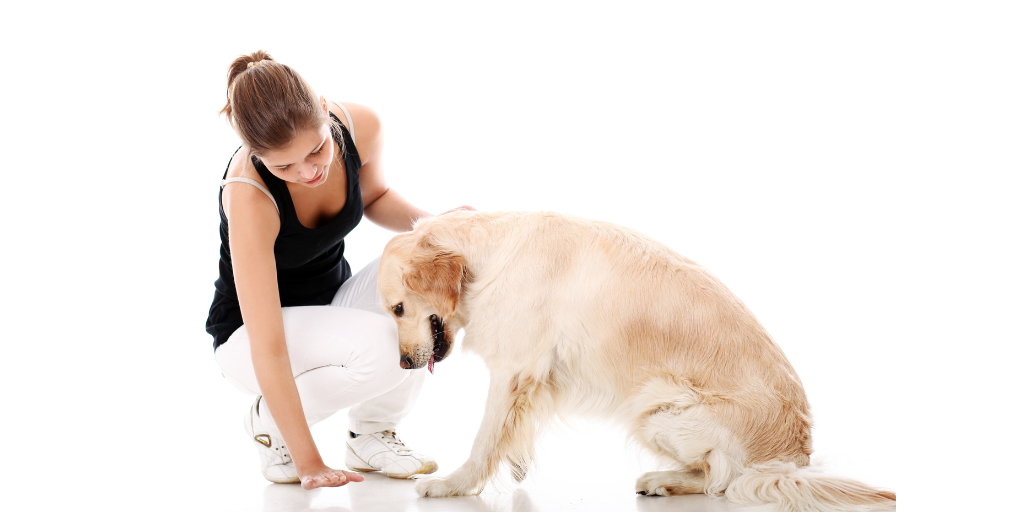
331,103,473,231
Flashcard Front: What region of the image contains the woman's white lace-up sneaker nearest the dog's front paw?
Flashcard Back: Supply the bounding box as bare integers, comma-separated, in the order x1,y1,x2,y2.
345,430,437,478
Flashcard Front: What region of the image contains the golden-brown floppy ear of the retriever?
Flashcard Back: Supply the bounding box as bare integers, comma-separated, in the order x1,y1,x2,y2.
401,239,469,318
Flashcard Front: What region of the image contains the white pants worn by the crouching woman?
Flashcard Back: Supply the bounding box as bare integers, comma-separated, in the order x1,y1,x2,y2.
216,258,426,437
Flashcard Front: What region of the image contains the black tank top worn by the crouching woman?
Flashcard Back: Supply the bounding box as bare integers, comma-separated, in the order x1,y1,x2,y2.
206,113,362,350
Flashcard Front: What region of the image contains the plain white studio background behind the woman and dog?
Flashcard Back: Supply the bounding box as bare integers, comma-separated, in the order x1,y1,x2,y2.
0,1,1024,510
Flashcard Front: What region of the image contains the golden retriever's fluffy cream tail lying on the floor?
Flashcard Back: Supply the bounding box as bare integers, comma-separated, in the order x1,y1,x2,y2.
725,462,896,512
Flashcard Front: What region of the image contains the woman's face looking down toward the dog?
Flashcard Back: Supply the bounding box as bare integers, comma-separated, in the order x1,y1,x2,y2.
260,124,334,188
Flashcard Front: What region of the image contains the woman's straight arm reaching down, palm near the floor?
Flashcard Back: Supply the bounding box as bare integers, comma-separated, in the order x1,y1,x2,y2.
223,159,362,488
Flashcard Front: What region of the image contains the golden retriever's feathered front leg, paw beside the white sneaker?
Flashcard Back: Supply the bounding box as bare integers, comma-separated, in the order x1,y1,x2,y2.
416,375,545,498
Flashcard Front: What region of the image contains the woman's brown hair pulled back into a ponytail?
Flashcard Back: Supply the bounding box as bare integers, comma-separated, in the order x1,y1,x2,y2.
220,50,344,157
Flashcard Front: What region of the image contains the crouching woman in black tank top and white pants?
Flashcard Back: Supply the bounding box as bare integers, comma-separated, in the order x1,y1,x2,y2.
207,51,468,489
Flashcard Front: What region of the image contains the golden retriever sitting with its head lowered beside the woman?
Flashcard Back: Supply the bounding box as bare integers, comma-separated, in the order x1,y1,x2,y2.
378,212,896,511
